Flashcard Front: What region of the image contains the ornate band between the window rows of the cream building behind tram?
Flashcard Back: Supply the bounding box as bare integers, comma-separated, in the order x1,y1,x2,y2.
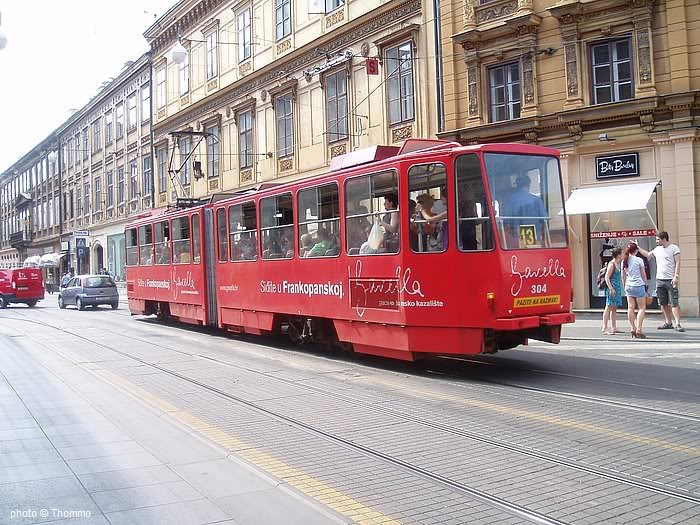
153,0,421,134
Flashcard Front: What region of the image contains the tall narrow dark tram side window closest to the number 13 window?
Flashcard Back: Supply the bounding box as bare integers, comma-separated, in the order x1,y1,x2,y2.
455,155,494,251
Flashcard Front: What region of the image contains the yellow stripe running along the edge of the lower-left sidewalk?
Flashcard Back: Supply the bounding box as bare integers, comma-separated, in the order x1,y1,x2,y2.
82,369,400,525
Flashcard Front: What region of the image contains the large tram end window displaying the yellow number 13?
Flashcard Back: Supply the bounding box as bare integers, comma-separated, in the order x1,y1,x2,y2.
484,153,567,250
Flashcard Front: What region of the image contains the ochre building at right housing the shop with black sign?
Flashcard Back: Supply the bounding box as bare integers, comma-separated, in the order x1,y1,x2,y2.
439,0,700,315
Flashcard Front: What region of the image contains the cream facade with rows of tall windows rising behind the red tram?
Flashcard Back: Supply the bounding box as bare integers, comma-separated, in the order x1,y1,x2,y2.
145,0,437,206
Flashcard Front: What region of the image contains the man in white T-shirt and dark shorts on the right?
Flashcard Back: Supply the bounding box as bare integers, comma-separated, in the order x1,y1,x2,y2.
639,232,685,332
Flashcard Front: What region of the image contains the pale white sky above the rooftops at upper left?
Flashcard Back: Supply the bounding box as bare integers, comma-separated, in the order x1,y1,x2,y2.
0,0,177,173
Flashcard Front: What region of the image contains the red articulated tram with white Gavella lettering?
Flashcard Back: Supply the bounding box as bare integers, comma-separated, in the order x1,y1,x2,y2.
126,140,574,360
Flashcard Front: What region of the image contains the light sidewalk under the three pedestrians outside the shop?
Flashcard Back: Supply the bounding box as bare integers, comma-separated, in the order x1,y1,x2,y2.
561,310,700,343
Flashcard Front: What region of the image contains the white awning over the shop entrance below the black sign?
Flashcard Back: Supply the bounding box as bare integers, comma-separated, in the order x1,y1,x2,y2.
564,182,657,215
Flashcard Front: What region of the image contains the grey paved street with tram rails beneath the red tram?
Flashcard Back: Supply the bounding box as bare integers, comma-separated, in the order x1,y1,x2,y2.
0,298,700,524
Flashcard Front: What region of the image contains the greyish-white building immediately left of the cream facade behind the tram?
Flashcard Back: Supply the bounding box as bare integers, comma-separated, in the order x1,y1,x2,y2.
56,54,153,280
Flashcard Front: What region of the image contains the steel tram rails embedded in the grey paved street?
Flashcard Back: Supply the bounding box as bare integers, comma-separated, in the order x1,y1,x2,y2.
5,304,700,512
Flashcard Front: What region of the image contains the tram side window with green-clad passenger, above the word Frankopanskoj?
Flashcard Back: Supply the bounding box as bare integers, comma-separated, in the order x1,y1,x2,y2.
297,184,340,257
